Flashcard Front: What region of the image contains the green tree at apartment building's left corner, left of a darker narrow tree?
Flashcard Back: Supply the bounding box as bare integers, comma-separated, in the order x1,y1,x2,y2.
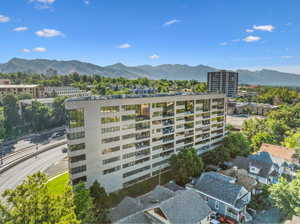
74,182,96,224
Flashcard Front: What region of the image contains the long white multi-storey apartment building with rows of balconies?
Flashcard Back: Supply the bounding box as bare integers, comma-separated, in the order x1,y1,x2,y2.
66,93,226,192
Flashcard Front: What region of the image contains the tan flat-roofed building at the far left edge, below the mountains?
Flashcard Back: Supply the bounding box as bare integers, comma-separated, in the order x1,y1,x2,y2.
0,84,42,99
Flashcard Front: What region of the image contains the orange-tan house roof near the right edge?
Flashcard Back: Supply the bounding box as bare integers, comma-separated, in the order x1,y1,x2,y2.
260,143,295,162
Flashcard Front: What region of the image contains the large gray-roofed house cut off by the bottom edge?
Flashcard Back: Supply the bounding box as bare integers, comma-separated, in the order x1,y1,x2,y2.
110,185,212,224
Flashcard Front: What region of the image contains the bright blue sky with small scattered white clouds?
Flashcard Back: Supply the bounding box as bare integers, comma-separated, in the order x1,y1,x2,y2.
0,0,300,74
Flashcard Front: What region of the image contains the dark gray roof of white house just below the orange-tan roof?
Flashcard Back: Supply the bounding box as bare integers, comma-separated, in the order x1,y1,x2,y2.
232,156,273,178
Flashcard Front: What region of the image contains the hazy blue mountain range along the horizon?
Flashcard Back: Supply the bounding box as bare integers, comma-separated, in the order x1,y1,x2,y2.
0,58,300,86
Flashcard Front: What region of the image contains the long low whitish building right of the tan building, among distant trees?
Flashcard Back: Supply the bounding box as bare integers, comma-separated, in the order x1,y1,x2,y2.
43,86,90,97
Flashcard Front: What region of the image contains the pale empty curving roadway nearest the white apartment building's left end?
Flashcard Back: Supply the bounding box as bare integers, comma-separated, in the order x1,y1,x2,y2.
0,145,67,194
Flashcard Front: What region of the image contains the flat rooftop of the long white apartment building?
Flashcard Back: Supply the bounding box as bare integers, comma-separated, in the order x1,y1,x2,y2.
66,92,225,102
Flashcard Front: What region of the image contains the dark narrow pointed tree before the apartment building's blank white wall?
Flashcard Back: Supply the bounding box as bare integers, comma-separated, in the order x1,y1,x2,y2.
90,180,109,223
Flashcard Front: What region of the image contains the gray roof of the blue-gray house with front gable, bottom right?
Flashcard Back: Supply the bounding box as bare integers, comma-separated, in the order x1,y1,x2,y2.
194,172,247,206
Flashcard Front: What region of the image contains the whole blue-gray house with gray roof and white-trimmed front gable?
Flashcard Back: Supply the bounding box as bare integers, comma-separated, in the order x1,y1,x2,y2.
186,172,252,223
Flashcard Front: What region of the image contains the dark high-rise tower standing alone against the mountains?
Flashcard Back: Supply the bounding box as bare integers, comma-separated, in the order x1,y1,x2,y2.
207,70,239,97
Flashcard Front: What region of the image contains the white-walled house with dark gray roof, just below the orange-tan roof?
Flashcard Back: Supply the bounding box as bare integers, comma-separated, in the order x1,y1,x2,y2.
231,155,282,184
